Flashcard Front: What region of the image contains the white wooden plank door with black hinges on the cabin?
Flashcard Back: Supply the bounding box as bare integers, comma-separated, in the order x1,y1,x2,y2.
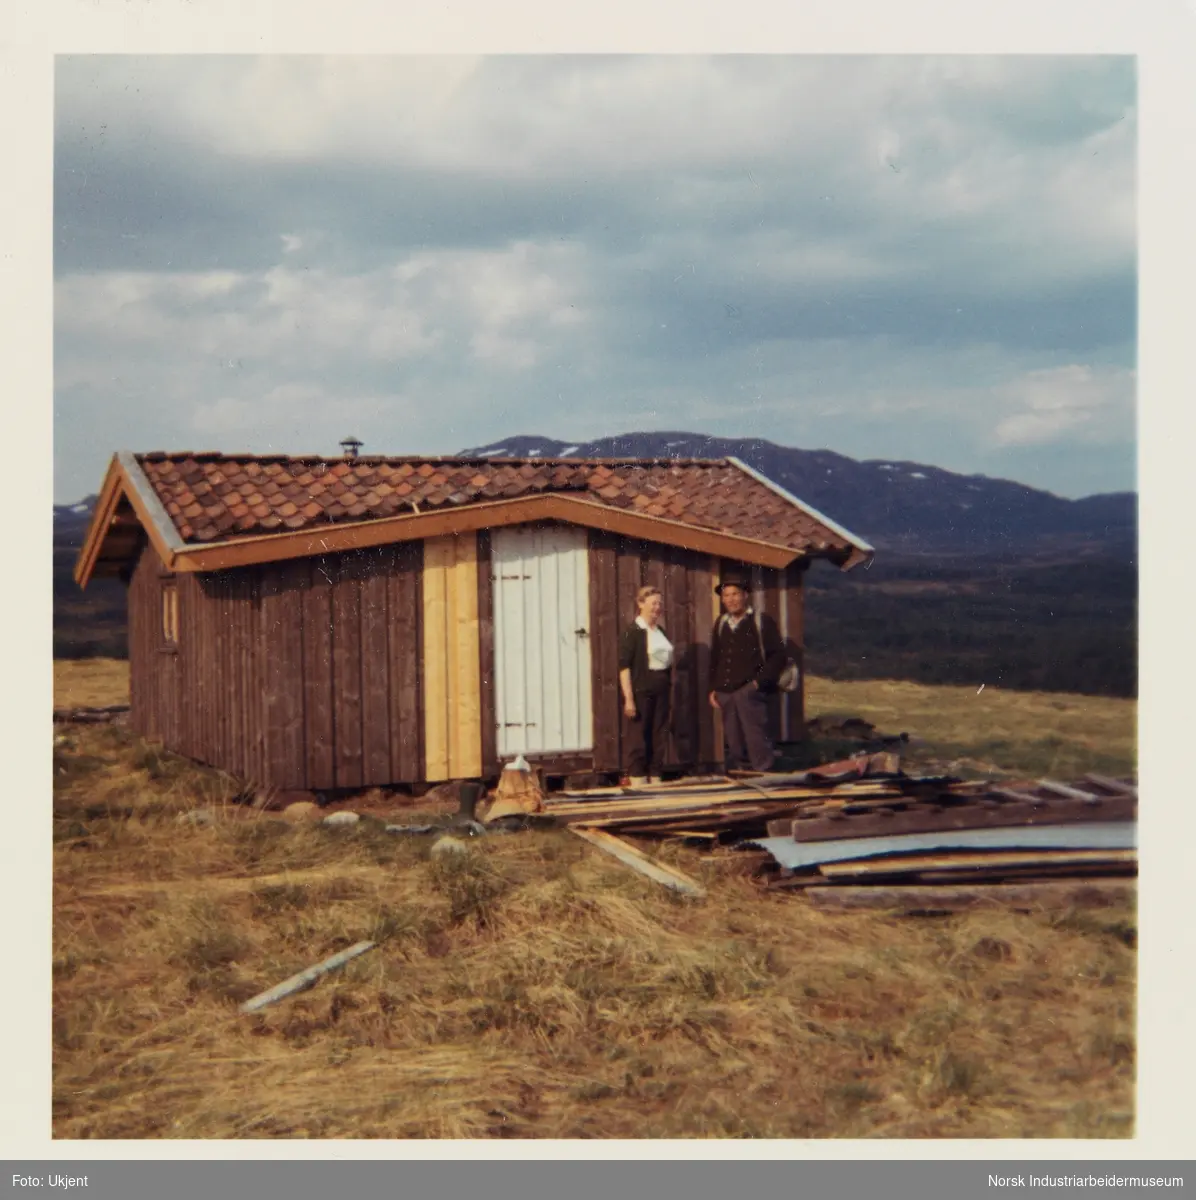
491,526,594,758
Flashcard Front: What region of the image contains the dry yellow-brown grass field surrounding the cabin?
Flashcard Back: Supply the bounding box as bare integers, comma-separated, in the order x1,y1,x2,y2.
53,661,1136,1139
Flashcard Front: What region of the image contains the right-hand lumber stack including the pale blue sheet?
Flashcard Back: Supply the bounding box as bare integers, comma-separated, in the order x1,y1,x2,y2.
753,775,1137,906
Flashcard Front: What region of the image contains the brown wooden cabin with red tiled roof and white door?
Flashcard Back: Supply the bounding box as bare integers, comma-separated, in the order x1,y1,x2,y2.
76,452,872,792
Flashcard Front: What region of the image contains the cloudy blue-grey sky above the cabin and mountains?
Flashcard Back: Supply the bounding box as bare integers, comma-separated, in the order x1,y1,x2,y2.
54,56,1137,503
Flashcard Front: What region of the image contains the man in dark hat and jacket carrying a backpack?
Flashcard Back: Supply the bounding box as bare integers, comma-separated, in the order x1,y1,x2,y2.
710,572,785,770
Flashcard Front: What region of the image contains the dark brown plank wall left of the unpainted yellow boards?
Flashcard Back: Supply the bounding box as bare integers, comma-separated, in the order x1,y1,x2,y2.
128,545,422,791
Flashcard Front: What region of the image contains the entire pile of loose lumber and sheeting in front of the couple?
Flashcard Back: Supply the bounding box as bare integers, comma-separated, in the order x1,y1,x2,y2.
542,754,1137,908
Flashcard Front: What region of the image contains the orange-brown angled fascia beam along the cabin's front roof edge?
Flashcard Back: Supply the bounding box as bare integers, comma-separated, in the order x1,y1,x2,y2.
173,493,801,571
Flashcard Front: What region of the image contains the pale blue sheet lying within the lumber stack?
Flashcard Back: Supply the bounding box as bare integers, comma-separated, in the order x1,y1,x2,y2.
751,821,1137,870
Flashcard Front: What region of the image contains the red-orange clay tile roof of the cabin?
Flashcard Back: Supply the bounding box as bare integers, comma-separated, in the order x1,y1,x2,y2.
137,451,852,554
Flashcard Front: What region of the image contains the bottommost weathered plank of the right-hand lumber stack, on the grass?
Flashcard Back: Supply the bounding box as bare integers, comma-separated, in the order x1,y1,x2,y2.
804,880,1136,912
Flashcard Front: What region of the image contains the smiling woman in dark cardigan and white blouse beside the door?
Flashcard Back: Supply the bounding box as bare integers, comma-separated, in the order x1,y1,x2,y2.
619,586,673,787
